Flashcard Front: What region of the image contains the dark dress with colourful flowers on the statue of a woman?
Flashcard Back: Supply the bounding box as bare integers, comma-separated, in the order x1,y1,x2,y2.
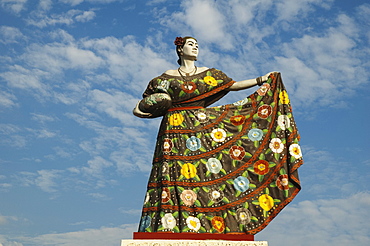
139,69,303,234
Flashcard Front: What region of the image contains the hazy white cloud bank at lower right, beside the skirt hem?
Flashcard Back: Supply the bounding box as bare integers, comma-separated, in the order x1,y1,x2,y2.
256,192,370,246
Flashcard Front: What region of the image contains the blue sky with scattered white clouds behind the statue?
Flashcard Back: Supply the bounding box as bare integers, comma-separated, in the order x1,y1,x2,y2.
0,0,370,246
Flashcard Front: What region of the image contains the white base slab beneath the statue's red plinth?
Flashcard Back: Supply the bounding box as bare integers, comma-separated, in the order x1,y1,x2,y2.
121,239,268,246
